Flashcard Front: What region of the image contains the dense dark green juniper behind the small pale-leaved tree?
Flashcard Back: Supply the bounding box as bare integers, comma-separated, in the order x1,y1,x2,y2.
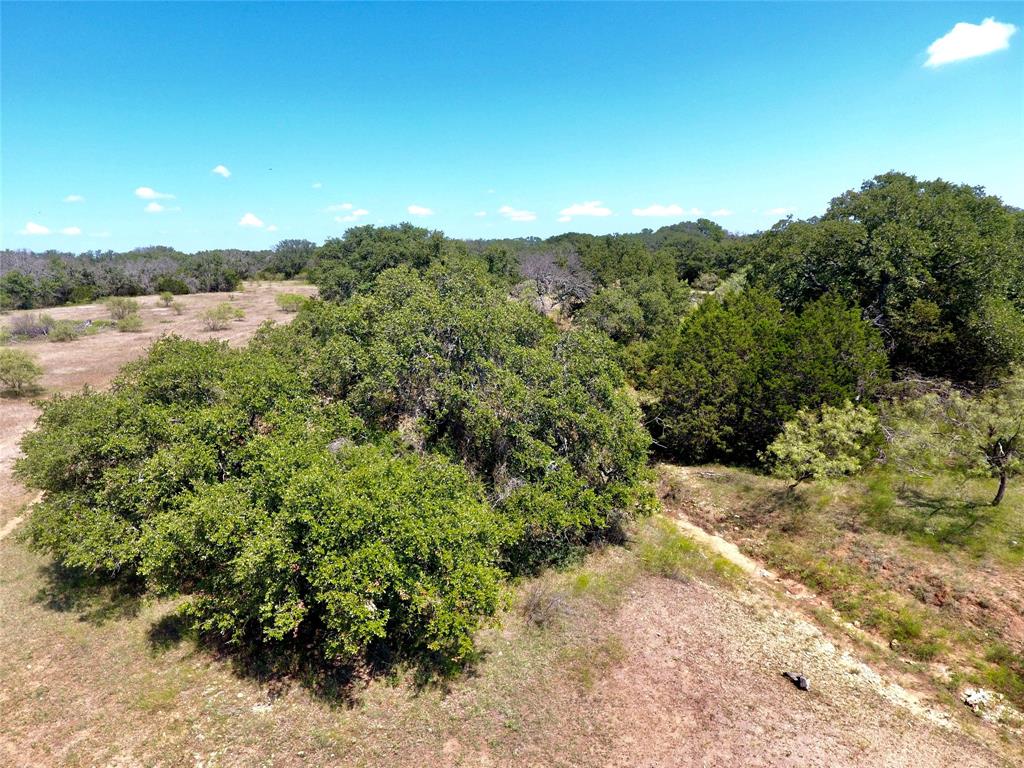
648,290,888,462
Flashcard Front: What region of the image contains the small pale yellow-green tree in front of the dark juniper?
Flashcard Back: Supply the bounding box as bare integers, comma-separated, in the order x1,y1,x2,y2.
765,400,879,486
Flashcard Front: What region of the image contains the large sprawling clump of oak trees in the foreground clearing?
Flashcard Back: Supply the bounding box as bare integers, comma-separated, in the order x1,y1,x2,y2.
16,268,649,663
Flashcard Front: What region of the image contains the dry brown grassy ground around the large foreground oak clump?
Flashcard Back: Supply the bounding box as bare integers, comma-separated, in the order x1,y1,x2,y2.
0,286,1021,768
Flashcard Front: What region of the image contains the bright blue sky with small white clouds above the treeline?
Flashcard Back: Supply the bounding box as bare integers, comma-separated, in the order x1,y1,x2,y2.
0,2,1024,251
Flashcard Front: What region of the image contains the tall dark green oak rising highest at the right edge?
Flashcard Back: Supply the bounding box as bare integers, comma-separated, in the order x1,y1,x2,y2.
752,173,1024,379
